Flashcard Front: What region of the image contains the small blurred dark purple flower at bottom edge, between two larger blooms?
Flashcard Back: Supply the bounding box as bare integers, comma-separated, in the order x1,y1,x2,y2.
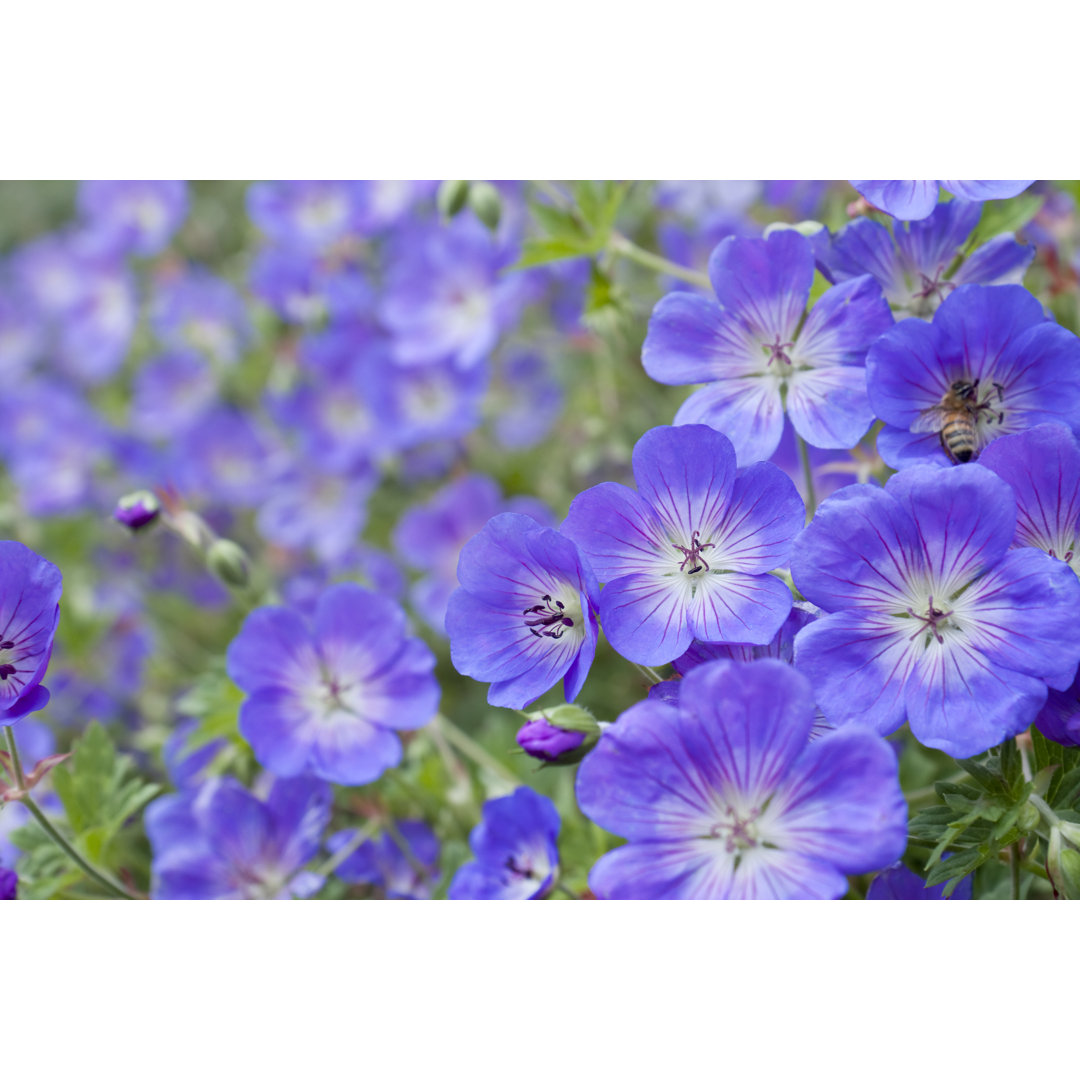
326,821,438,900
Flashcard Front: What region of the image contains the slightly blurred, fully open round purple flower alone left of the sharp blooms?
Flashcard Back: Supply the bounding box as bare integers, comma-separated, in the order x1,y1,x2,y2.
226,583,438,784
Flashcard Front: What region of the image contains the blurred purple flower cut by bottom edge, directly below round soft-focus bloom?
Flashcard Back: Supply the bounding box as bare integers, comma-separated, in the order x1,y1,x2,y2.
146,777,333,900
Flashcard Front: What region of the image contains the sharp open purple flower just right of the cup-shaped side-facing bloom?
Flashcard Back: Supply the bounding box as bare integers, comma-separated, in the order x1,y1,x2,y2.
563,424,805,664
